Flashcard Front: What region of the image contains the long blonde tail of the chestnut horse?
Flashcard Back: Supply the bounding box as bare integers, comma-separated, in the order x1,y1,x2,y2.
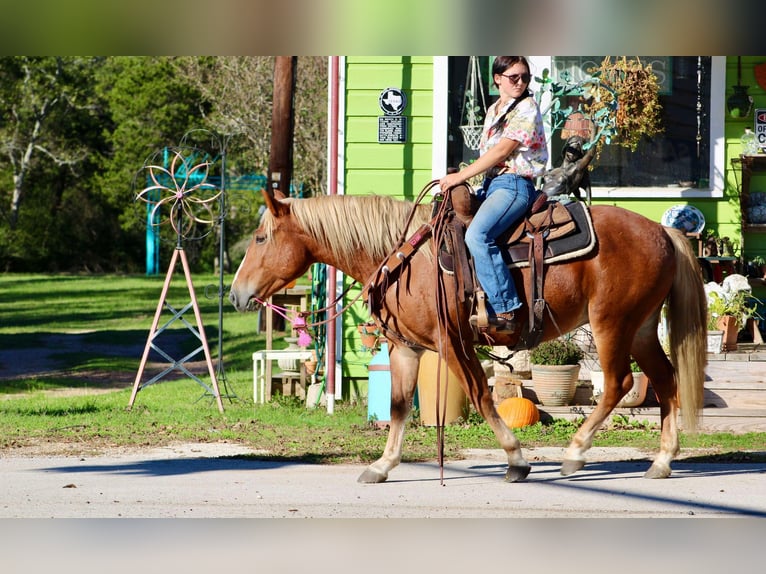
665,229,707,432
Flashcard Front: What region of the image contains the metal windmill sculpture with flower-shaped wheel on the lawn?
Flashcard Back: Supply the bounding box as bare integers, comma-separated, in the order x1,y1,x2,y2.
128,148,223,412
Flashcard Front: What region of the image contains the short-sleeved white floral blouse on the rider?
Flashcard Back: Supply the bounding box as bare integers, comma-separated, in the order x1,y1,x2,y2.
479,96,548,178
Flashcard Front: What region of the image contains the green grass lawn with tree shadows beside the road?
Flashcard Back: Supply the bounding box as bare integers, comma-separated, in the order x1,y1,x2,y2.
0,273,766,463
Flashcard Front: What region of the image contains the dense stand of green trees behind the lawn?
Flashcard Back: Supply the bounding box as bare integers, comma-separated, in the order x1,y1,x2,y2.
0,57,327,271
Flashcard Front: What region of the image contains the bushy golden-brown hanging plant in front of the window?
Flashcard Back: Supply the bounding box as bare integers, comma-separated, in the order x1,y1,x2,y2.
584,56,664,151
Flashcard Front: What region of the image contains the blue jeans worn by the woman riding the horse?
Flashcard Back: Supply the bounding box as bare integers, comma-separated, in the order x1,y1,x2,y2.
465,174,537,314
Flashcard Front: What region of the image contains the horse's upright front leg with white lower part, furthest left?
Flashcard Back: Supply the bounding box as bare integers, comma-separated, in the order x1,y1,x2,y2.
357,342,423,483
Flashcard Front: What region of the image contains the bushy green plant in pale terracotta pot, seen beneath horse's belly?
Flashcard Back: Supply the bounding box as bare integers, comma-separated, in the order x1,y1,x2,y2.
529,338,585,407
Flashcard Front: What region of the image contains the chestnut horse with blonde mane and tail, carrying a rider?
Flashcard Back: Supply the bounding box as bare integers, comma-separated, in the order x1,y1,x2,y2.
229,193,706,483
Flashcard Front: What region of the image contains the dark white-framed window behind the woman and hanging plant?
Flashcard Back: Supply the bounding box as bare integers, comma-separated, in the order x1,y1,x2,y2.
446,56,726,198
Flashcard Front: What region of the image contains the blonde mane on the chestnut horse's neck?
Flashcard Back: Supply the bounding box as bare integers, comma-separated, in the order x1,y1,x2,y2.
261,195,430,272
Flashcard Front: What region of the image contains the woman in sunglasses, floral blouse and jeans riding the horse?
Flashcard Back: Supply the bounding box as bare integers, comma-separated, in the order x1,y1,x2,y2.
439,56,548,333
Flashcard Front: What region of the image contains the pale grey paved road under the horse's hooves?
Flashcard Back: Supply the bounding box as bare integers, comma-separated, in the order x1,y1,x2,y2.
0,445,766,518
